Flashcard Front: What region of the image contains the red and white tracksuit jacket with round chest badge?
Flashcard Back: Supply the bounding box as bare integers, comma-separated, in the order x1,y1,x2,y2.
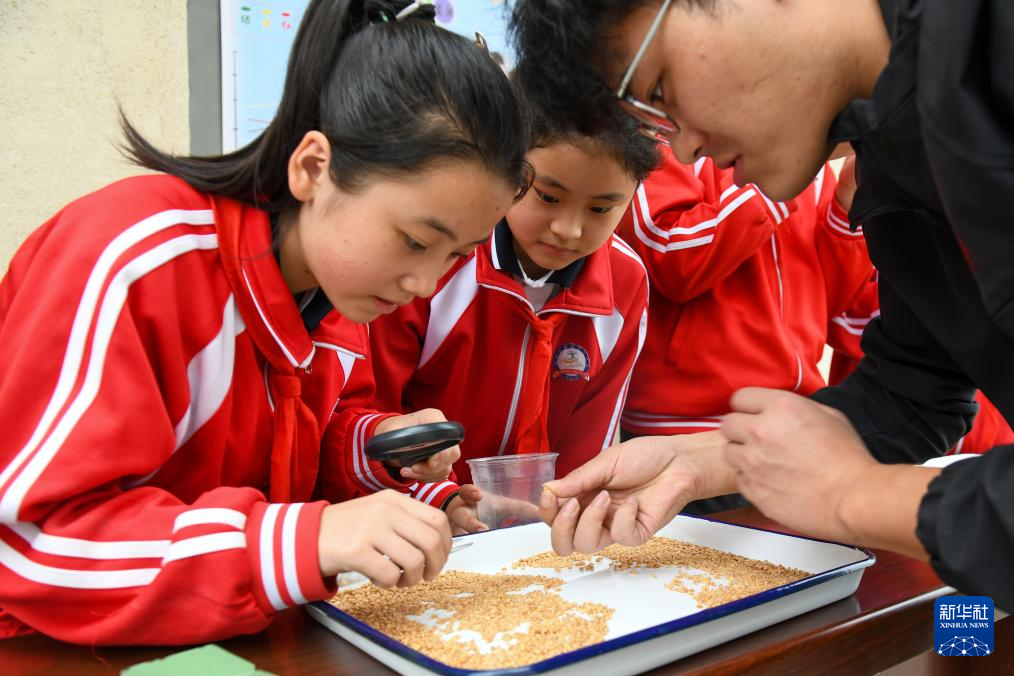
342,224,648,500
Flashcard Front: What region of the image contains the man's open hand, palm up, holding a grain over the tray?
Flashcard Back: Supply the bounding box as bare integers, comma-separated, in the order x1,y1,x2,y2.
538,432,731,555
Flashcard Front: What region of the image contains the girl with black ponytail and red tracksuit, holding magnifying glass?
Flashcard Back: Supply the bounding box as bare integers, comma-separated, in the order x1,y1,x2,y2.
0,0,525,644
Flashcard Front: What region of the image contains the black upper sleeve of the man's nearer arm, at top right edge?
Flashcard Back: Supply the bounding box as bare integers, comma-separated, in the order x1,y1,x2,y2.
917,0,1014,335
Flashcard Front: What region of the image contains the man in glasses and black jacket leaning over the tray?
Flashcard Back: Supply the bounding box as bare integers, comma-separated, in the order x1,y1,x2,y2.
513,0,1014,610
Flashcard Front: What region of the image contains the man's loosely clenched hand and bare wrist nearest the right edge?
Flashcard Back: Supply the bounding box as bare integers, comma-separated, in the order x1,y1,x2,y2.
722,387,940,560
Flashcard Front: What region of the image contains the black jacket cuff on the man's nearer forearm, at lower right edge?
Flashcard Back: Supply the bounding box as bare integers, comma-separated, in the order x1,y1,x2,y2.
916,446,1014,612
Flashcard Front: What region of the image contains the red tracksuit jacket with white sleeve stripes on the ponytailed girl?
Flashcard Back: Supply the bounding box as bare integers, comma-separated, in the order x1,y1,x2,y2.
0,175,403,645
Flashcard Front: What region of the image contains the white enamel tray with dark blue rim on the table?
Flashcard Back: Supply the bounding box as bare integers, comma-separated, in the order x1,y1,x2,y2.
306,515,876,676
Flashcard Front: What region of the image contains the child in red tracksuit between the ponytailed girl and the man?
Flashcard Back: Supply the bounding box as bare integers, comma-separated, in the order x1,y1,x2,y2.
338,89,658,529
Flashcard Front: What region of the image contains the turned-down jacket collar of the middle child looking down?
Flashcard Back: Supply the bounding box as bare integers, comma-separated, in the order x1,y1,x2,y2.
476,220,613,316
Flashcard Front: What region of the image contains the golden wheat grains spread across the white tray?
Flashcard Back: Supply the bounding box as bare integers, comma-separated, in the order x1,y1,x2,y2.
331,537,809,670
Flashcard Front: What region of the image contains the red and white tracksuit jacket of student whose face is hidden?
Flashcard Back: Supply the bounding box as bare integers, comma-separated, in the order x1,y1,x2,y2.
619,148,872,435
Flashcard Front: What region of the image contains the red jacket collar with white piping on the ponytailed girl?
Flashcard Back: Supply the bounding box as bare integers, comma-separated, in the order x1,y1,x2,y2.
212,196,366,373
